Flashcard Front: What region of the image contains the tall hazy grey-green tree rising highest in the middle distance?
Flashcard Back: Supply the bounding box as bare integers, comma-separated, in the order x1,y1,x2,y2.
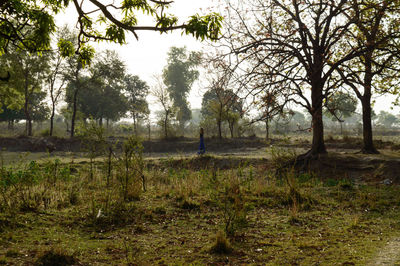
163,47,200,136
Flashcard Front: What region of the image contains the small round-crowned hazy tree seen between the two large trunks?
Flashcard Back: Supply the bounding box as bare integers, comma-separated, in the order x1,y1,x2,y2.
325,91,357,135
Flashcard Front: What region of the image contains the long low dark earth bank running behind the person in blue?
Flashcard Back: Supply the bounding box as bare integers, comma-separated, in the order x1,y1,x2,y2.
0,136,400,154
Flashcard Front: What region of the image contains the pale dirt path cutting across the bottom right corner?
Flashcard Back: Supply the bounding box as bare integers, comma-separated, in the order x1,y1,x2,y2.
368,236,400,265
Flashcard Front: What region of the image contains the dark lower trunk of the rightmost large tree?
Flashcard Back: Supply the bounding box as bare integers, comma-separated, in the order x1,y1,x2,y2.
361,94,379,154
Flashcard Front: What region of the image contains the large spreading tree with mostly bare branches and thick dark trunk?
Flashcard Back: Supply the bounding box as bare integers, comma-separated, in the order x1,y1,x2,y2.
220,0,368,158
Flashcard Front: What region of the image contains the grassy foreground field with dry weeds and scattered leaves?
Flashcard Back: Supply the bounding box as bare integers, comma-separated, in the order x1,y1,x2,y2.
0,151,400,265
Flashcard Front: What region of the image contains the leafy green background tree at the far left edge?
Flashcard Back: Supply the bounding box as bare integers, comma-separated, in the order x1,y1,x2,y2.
2,51,49,136
